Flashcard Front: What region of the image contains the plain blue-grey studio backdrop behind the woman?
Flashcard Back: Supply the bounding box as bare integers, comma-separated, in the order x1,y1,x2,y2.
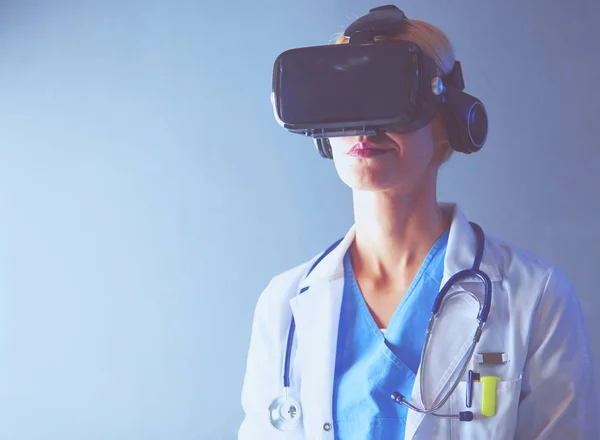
0,0,600,440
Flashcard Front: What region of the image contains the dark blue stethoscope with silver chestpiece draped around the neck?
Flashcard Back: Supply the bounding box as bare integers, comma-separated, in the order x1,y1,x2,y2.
269,223,492,431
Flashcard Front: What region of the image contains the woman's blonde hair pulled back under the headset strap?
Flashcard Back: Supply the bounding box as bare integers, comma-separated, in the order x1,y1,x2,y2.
335,19,456,163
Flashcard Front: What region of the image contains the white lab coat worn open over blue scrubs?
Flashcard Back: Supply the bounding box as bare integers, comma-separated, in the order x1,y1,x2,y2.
238,204,600,440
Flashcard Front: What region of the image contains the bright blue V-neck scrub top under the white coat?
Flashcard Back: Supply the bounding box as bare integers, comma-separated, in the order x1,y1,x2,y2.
333,231,449,440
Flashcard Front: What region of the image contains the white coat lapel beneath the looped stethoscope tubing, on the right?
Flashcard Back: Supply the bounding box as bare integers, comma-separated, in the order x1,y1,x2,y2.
405,204,501,439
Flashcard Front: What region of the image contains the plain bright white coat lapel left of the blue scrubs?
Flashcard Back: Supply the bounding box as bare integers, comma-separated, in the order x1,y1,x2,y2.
290,228,354,438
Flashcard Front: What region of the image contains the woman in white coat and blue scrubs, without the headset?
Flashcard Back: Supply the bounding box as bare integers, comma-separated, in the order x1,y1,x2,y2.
239,6,600,440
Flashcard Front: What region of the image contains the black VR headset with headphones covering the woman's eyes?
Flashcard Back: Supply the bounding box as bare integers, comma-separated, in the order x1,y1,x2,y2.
271,5,488,159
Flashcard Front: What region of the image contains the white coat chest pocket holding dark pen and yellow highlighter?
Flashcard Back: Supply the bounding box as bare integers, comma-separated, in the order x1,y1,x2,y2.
450,376,522,440
